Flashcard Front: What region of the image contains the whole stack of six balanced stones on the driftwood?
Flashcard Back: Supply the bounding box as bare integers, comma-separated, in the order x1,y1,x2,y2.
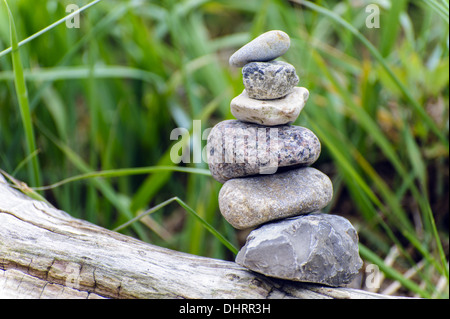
207,31,362,286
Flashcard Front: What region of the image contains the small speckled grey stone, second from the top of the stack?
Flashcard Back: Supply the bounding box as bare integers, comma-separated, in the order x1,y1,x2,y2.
242,61,299,100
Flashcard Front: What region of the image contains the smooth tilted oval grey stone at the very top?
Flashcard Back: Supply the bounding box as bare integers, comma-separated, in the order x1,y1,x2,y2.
229,30,291,68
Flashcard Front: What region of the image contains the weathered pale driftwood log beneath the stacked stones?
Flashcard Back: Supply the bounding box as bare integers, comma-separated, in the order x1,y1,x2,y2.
0,174,404,299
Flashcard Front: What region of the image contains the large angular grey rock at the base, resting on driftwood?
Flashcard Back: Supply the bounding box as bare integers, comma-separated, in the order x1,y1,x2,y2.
236,214,363,287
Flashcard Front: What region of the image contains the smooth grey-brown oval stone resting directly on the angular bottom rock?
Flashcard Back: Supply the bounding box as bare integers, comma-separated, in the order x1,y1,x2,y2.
219,167,333,229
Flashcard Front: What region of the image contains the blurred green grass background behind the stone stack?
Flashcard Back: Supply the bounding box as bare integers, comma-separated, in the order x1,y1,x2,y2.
0,0,449,298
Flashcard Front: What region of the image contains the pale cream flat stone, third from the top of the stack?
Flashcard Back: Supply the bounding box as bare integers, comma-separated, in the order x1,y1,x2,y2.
230,87,309,126
